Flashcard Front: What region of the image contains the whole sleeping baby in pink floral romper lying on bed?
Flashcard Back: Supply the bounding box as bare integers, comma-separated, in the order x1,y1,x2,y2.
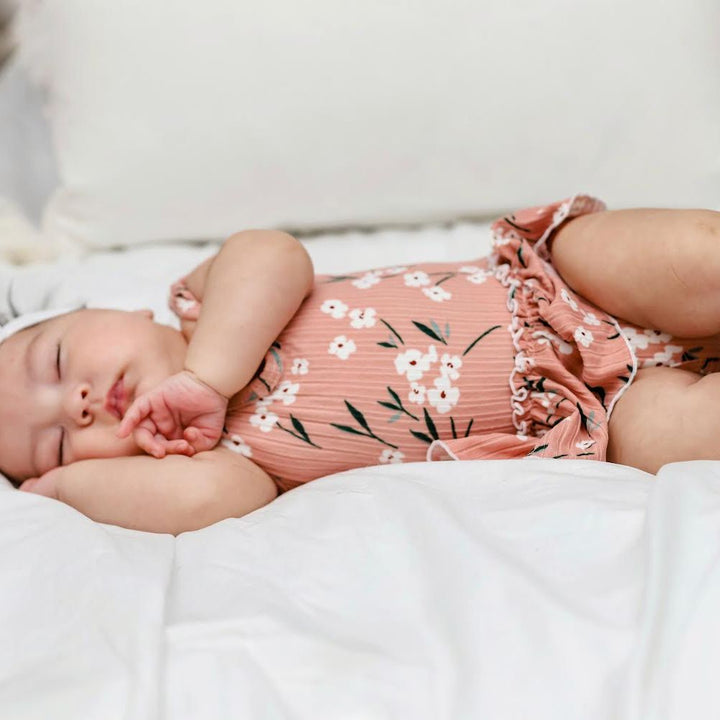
5,195,720,534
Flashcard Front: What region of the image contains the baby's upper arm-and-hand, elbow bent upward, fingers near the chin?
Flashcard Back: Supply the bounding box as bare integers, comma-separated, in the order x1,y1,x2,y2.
118,230,314,457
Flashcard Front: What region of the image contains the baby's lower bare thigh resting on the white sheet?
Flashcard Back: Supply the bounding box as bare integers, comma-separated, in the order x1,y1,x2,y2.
607,367,720,473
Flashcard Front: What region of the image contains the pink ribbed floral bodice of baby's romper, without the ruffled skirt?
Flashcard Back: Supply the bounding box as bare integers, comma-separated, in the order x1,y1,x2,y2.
221,258,514,489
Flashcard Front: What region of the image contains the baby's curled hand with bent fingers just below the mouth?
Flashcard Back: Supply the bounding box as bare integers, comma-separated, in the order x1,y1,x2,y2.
117,370,228,458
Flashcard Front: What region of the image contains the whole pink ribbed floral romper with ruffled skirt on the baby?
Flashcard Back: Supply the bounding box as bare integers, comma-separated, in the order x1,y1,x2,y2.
170,195,720,491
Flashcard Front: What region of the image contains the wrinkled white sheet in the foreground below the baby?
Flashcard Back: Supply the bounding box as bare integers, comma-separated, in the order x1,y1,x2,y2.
0,459,720,720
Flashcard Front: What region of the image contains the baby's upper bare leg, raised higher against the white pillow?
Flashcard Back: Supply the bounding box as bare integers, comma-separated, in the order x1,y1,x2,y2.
551,209,720,338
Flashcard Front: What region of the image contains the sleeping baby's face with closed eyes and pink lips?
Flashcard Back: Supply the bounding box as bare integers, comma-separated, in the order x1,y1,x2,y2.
0,310,187,480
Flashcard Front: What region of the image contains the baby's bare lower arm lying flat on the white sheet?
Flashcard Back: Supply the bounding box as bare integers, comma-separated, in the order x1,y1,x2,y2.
20,447,277,535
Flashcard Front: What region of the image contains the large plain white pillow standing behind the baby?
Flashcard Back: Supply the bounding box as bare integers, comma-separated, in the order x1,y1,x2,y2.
14,0,720,246
